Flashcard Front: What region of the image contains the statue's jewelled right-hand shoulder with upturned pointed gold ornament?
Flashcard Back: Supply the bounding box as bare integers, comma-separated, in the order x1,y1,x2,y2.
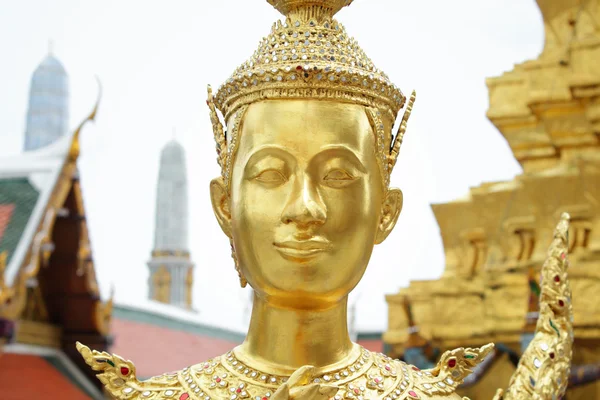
382,344,494,400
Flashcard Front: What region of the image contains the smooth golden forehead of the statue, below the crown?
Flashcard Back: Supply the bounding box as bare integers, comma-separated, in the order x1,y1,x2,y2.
241,100,373,150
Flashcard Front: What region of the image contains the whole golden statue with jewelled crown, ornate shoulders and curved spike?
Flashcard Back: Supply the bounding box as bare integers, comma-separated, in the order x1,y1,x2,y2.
78,0,571,400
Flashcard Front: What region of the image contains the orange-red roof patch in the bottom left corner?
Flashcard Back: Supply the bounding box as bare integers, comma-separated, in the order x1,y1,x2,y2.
0,353,89,400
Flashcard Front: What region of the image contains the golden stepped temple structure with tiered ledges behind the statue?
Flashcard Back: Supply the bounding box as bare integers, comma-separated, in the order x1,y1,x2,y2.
384,0,600,400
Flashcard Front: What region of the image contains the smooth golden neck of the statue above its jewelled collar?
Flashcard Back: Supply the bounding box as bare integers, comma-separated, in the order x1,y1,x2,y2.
235,294,360,375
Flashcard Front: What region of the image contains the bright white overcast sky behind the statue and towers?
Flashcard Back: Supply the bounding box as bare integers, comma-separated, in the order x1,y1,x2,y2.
0,0,543,331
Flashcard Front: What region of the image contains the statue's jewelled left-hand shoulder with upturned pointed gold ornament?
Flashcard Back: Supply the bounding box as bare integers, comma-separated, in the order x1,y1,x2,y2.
77,343,235,400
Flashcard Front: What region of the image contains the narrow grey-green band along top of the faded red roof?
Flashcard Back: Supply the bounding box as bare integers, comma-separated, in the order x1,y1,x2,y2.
112,305,245,343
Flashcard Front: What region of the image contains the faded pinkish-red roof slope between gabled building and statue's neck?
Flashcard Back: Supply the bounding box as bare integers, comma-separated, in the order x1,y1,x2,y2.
110,318,239,378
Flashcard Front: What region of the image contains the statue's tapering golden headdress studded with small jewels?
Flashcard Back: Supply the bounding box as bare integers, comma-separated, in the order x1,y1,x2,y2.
209,0,405,121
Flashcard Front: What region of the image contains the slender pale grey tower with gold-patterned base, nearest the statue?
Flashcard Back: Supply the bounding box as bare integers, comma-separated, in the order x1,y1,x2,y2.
148,140,194,308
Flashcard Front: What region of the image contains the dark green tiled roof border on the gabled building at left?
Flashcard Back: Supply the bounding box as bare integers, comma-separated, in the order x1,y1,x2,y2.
0,178,39,264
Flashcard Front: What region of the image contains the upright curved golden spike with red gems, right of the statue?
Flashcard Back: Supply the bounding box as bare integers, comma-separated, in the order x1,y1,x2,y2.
494,213,573,400
